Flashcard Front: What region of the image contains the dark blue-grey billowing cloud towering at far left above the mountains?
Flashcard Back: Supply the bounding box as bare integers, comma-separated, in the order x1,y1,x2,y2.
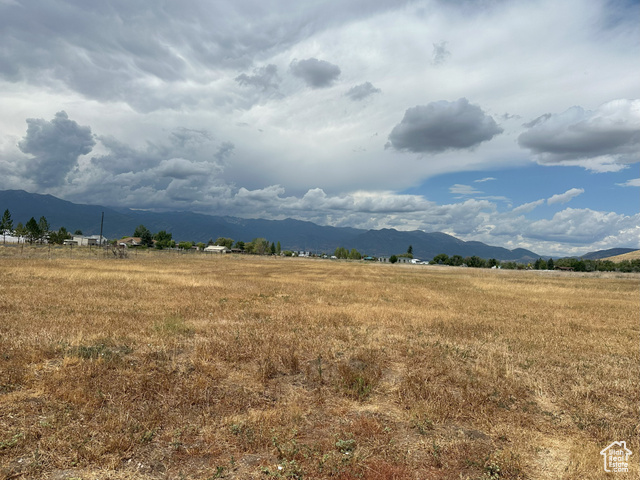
18,111,96,187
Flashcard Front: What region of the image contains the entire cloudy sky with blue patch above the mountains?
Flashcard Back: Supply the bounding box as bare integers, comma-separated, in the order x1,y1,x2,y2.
0,0,640,255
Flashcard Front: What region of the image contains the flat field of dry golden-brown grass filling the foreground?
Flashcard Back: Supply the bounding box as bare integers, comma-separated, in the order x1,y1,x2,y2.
0,247,640,480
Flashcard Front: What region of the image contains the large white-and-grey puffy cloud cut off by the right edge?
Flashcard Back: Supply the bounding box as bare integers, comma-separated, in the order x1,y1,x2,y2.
518,99,640,171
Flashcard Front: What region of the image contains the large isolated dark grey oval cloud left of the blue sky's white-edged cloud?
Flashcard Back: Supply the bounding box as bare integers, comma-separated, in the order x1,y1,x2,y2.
387,98,502,153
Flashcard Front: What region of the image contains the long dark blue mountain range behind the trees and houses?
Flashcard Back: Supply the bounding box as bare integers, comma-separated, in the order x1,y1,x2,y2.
0,190,539,263
